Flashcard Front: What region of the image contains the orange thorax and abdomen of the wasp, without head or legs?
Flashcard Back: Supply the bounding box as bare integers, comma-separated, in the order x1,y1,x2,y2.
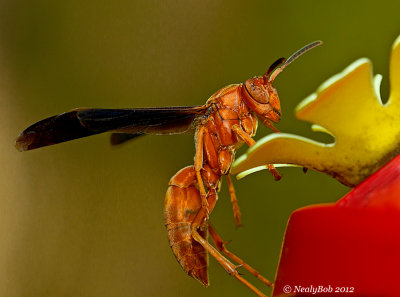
165,84,258,286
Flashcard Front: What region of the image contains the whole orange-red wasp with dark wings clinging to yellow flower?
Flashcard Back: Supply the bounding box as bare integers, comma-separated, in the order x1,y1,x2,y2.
16,41,322,296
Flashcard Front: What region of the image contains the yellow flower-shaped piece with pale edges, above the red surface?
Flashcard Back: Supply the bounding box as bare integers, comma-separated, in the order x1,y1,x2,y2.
232,36,400,186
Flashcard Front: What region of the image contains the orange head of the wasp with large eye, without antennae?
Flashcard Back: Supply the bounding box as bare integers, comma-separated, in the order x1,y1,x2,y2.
242,77,281,127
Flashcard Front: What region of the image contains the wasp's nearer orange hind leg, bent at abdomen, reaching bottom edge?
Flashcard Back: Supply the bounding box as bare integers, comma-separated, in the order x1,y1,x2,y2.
191,214,266,297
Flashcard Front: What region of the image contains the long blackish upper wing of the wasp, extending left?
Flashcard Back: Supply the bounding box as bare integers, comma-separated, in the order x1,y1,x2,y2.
15,105,207,151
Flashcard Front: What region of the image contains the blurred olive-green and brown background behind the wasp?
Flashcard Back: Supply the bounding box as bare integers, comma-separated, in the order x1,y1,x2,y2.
0,0,400,297
